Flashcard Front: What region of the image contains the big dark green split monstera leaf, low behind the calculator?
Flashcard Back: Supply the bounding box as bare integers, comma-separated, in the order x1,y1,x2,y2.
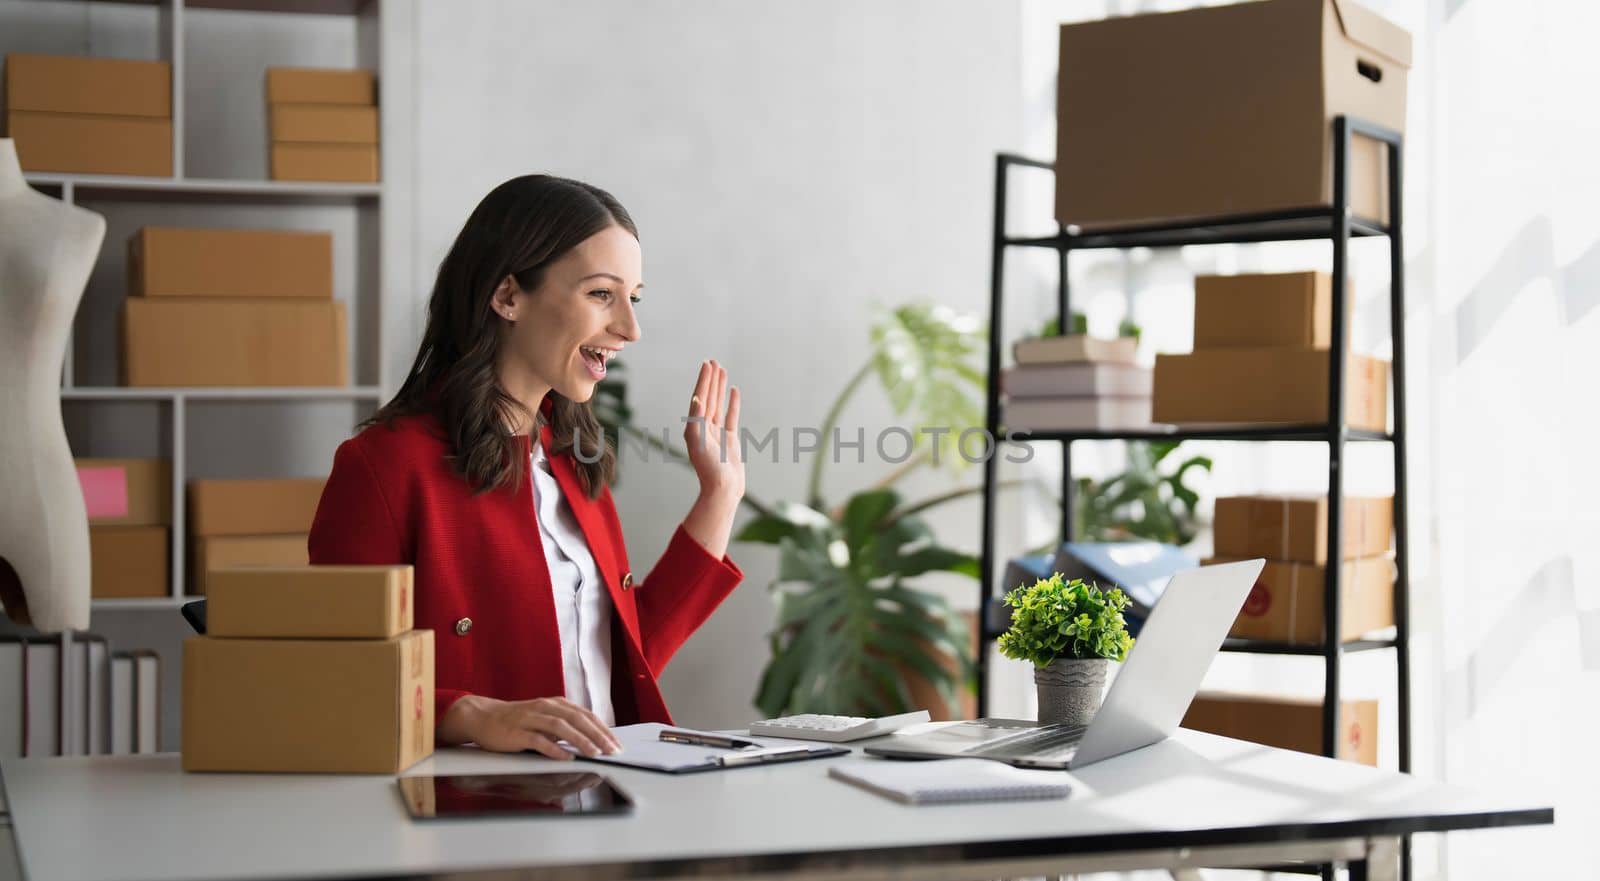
739,489,978,716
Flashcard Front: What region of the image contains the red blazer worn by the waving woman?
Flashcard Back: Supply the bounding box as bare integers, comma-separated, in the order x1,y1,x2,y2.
309,400,744,724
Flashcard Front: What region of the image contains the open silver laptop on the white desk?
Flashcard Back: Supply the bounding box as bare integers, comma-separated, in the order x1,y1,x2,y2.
866,560,1266,771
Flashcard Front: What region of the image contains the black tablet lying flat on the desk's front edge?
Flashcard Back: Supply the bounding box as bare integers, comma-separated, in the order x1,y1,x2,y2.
400,771,634,820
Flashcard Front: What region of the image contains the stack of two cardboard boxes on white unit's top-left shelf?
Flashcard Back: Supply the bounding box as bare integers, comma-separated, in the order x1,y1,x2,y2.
5,53,173,177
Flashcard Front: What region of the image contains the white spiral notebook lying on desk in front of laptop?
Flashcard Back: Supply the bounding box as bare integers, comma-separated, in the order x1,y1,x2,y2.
827,758,1074,804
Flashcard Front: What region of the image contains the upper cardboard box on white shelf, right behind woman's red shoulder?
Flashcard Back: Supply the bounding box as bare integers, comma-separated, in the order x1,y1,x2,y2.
189,476,328,536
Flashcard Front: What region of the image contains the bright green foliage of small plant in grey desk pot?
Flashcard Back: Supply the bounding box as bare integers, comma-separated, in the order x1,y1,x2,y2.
998,572,1133,667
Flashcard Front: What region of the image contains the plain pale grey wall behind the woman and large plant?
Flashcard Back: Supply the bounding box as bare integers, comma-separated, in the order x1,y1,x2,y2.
403,0,1019,726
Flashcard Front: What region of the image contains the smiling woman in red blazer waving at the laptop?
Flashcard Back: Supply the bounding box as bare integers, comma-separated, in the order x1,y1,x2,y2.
309,174,744,758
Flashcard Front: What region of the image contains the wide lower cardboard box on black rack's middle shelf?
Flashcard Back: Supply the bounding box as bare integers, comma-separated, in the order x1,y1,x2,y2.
1154,349,1389,432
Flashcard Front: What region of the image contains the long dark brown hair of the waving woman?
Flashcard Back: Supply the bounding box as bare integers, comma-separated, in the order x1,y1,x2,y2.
363,174,638,499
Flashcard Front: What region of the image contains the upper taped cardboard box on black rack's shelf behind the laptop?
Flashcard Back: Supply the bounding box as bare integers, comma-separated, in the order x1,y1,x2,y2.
1213,496,1394,564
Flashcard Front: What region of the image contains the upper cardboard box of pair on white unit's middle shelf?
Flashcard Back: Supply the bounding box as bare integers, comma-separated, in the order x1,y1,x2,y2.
128,227,333,301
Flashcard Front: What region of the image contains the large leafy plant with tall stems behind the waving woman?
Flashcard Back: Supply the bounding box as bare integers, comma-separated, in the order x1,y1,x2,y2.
736,304,1004,716
